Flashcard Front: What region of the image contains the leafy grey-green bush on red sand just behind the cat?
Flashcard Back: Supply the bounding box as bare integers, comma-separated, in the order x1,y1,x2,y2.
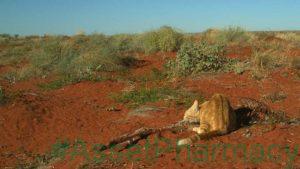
166,42,230,76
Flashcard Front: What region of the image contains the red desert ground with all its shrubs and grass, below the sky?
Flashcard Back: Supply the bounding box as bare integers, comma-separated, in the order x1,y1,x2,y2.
0,27,300,169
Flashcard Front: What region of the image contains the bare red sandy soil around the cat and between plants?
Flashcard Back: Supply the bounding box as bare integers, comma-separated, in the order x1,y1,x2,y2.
0,48,300,169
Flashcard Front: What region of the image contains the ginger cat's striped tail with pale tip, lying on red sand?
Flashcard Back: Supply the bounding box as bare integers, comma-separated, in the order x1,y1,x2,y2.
177,131,221,146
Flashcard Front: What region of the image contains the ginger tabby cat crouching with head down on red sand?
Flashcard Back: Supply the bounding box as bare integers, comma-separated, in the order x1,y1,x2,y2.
178,94,236,145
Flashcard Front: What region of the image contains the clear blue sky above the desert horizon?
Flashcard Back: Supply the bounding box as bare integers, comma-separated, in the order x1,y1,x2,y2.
0,0,300,35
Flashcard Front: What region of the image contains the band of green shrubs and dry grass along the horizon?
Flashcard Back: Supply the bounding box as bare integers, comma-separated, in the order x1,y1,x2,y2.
0,26,300,88
